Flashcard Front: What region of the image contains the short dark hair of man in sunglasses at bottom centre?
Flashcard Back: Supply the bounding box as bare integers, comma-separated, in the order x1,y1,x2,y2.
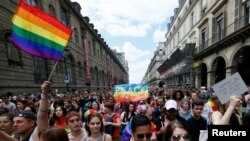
131,114,151,132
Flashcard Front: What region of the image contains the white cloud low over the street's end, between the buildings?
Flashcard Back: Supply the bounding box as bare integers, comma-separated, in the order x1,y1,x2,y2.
112,42,151,83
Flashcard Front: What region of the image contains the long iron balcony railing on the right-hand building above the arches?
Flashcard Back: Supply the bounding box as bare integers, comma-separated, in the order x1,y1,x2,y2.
195,15,250,54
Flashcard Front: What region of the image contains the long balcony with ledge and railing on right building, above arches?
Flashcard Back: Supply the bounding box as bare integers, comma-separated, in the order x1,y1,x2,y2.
194,15,250,60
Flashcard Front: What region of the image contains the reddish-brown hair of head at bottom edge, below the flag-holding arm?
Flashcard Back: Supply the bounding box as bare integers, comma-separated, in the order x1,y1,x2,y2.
39,127,69,141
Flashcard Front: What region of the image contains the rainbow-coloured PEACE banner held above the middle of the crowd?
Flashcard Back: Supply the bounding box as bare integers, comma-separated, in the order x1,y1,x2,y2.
114,84,149,102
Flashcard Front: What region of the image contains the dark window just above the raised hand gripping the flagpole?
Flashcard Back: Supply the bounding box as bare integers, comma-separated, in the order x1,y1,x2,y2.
33,56,47,84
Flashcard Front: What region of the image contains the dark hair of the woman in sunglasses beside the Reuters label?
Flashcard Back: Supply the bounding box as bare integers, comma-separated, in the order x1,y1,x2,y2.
165,120,190,141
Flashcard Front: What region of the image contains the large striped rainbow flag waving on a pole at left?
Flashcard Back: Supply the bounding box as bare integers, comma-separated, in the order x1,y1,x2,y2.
11,0,72,61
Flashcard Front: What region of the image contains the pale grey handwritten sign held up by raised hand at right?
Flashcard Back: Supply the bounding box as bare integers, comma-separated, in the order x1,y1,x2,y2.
212,72,248,104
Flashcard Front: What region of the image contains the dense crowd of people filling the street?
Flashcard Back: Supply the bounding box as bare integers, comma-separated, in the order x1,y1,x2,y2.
0,81,250,141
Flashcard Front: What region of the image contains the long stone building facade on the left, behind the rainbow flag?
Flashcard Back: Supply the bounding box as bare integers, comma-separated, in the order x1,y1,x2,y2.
0,0,128,94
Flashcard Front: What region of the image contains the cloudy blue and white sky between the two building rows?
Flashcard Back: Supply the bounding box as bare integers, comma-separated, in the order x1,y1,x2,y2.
72,0,178,84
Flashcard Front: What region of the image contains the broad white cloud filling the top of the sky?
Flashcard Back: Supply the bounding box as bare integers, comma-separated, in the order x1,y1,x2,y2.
76,0,178,37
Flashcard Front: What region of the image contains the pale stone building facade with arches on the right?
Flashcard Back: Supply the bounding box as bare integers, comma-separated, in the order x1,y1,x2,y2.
158,0,250,88
